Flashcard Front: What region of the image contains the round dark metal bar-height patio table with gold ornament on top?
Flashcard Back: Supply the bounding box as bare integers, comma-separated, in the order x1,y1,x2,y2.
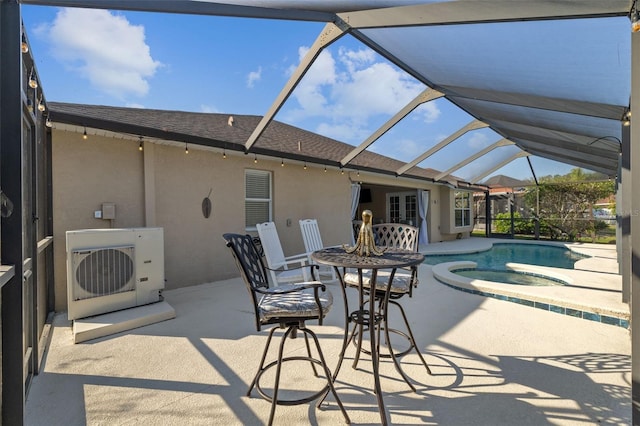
311,247,424,425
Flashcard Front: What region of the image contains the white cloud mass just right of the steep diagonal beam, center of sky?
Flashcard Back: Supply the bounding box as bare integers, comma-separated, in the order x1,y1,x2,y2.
286,47,440,143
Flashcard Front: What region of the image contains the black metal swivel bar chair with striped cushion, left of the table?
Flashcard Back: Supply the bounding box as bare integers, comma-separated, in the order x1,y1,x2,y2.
223,233,350,425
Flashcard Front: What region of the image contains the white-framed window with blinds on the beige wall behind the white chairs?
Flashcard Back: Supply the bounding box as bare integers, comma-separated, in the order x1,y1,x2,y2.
244,170,273,231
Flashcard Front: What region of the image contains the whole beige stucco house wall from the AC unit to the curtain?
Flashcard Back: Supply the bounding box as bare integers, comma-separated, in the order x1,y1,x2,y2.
52,130,351,311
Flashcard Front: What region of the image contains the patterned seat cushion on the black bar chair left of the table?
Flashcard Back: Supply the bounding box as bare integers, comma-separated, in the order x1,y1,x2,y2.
258,281,333,320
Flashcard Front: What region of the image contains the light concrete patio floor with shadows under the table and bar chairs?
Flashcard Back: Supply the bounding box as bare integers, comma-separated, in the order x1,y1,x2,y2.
25,239,631,426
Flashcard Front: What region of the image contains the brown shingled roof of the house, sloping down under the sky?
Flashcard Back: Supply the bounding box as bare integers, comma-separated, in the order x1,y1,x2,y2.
48,102,480,189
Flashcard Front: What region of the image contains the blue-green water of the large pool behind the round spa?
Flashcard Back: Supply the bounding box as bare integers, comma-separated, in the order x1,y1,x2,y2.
424,243,589,270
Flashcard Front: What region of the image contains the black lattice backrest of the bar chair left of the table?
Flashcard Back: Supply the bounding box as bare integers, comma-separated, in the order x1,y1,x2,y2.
222,234,269,331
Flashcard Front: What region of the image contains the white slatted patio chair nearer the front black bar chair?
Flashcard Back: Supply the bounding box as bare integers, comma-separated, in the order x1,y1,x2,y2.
256,222,309,286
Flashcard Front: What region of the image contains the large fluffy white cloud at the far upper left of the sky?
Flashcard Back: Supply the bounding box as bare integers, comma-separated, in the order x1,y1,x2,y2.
46,8,161,98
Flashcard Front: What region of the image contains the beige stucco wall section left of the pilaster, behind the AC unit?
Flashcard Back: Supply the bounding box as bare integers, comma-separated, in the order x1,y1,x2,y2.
52,130,144,311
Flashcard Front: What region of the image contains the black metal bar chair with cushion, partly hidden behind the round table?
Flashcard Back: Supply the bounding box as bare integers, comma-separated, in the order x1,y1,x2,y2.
344,223,431,391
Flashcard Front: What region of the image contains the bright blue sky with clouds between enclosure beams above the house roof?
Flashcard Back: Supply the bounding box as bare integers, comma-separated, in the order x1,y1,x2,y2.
22,5,573,179
